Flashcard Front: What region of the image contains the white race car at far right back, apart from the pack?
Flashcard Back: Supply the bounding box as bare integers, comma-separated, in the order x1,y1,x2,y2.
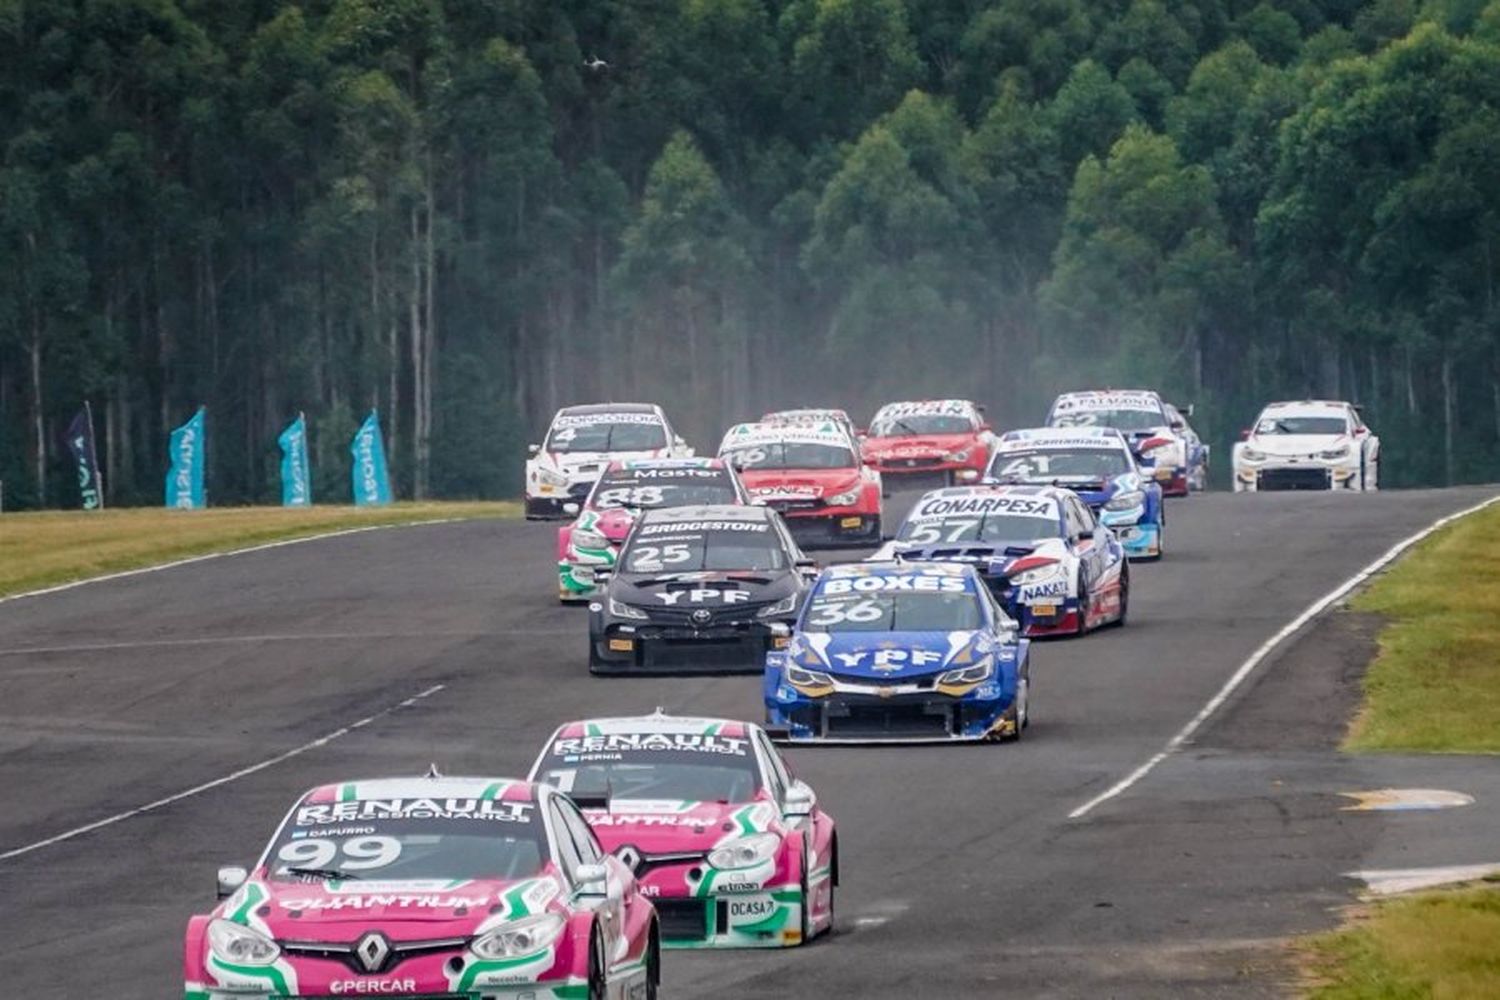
1233,399,1380,493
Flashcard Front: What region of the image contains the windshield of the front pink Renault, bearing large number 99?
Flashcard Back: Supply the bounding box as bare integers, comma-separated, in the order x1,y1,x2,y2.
266,798,548,882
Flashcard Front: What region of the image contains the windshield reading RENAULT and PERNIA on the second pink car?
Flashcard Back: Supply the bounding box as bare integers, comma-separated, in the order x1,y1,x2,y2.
539,733,761,802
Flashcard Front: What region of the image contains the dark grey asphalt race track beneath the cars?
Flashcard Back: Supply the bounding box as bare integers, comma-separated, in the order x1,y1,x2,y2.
0,489,1493,1000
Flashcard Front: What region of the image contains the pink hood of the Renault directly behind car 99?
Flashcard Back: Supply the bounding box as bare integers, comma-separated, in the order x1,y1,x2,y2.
585,799,780,855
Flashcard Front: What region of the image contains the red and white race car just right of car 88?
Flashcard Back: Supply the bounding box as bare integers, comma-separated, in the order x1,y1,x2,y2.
719,421,882,547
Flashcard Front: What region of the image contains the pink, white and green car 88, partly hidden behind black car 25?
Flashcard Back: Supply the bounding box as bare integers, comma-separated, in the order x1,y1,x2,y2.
558,459,750,603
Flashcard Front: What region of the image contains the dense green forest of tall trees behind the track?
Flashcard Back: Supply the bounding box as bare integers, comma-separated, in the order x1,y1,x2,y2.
0,0,1500,510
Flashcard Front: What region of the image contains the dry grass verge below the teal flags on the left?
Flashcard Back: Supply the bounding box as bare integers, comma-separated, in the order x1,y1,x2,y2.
0,502,521,597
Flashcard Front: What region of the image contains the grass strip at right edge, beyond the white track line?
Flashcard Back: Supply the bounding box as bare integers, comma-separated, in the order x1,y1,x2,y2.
1344,507,1500,749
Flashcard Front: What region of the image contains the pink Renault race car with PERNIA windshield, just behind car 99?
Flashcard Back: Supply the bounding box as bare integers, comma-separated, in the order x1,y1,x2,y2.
531,711,839,948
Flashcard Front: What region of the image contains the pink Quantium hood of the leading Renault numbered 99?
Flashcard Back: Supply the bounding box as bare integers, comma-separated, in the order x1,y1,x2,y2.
221,870,563,942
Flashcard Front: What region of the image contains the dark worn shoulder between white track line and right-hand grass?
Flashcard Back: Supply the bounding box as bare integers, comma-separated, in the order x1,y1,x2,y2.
1197,610,1385,751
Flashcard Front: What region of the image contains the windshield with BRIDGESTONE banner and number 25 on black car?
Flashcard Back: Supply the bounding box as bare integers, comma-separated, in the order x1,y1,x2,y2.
623,520,792,574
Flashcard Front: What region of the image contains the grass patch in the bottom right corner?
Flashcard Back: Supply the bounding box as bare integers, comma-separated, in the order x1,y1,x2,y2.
1299,882,1500,1000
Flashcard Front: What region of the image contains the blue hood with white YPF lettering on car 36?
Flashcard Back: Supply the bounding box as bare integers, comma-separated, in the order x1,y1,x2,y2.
794,631,993,682
